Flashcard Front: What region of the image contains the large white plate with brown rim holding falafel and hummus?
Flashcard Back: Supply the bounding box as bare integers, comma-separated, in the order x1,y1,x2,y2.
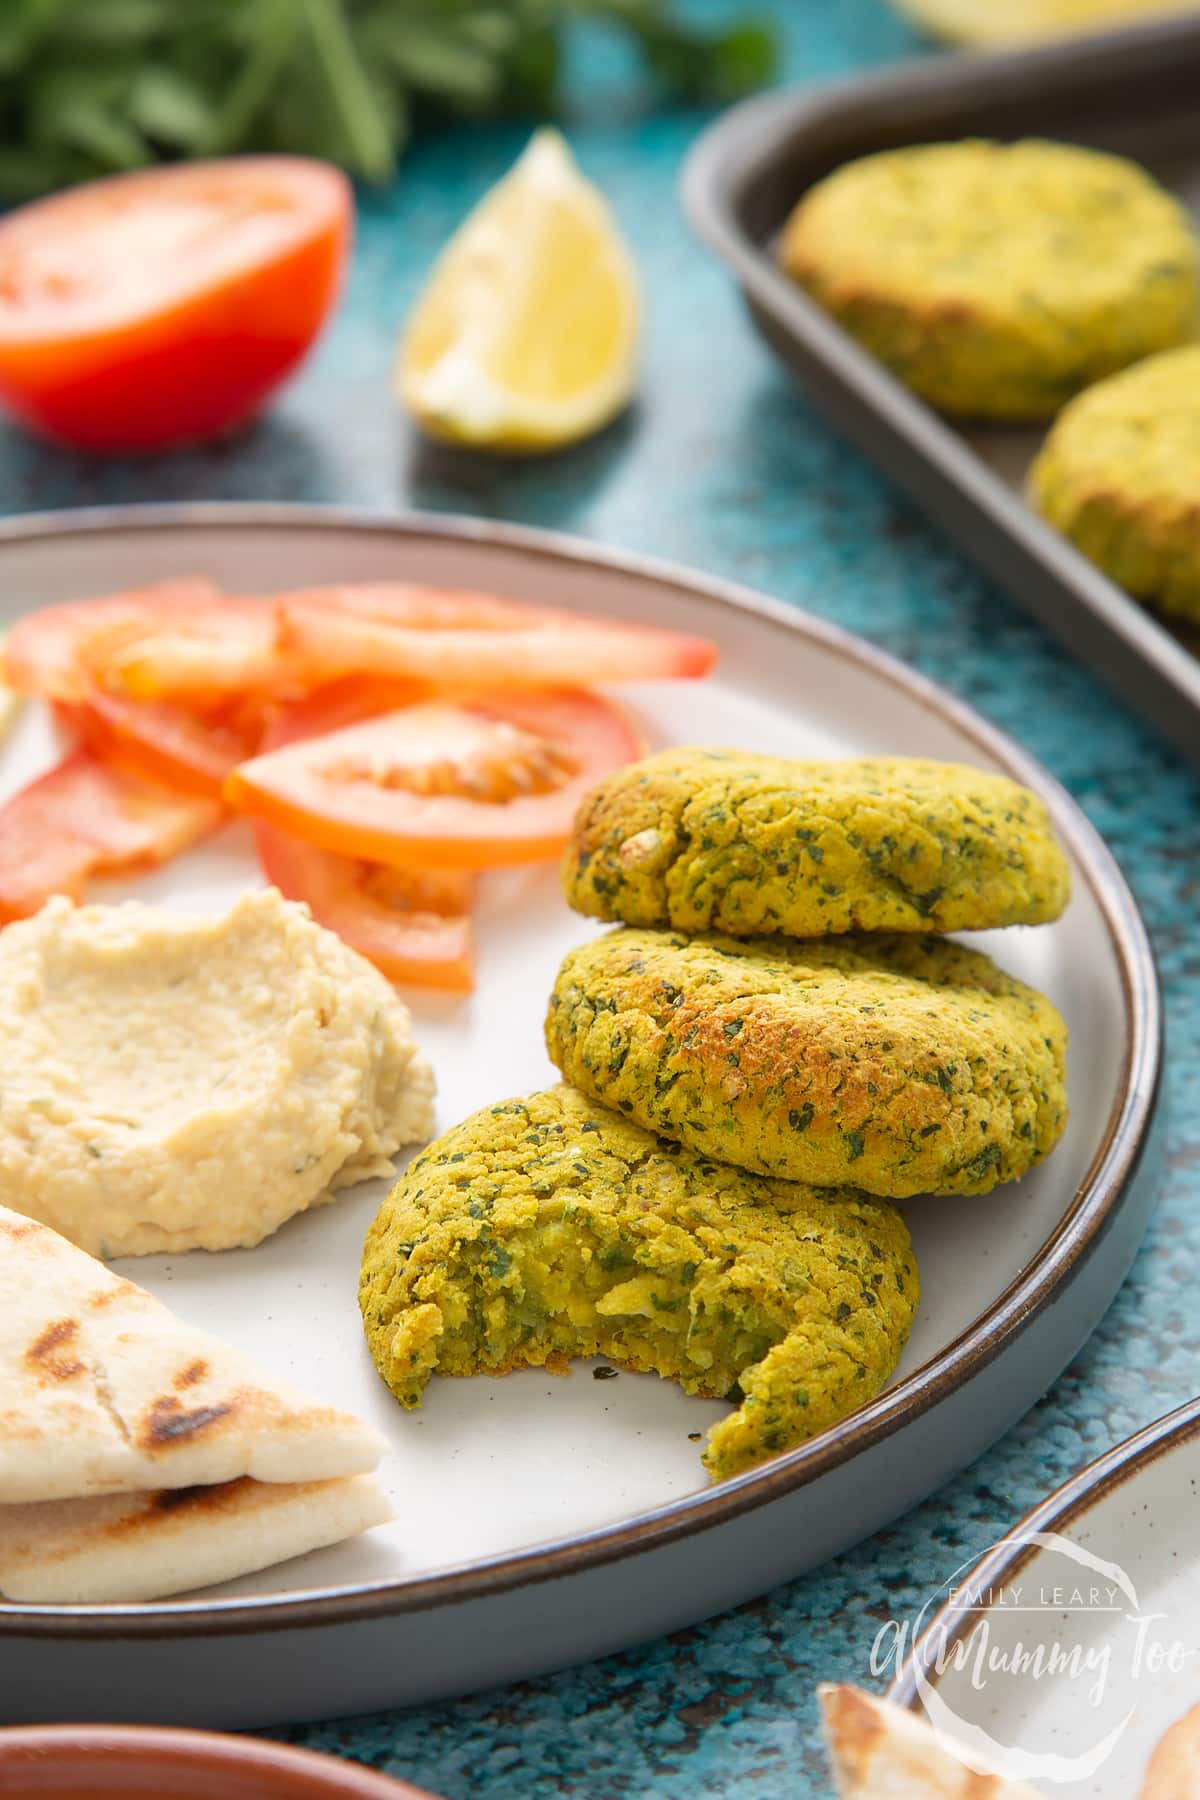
0,506,1160,1724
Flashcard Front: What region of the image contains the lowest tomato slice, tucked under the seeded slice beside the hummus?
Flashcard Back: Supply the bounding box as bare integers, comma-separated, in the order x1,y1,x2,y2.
255,824,475,994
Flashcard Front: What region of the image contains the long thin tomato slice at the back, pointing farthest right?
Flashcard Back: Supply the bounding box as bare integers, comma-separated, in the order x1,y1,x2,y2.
277,583,716,693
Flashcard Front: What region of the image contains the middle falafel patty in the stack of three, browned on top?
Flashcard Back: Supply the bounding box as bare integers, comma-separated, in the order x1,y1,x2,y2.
545,929,1067,1199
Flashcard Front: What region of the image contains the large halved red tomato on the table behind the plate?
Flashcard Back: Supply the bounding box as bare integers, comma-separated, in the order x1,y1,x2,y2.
0,157,353,450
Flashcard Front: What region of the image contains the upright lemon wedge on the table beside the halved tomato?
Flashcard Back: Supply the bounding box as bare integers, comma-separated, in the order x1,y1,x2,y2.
396,131,639,450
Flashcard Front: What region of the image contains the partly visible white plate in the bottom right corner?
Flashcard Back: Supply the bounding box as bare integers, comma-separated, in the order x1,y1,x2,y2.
889,1400,1200,1800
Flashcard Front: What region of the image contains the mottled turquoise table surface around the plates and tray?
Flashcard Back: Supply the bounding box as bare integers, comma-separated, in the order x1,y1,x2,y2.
0,0,1200,1800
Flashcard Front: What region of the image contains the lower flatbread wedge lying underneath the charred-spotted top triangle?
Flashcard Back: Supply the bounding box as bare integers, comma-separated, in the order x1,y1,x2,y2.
0,1474,392,1606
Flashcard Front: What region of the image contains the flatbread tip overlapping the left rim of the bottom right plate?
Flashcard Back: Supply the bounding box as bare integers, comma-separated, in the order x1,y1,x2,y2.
817,1681,1040,1800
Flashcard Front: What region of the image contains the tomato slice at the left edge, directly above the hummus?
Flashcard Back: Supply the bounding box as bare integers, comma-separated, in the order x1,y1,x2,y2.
0,751,223,922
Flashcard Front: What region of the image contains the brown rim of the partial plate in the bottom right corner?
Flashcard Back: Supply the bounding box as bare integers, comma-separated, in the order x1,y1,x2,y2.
887,1399,1200,1712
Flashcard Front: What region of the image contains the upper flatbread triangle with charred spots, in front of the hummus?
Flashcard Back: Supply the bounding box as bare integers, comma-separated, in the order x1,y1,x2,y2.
0,1208,387,1505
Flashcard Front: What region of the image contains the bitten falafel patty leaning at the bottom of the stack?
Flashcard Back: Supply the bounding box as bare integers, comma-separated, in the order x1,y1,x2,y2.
358,1087,918,1480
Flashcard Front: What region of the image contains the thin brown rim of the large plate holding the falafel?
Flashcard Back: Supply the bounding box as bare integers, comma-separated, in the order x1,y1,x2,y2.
0,502,1162,1638
